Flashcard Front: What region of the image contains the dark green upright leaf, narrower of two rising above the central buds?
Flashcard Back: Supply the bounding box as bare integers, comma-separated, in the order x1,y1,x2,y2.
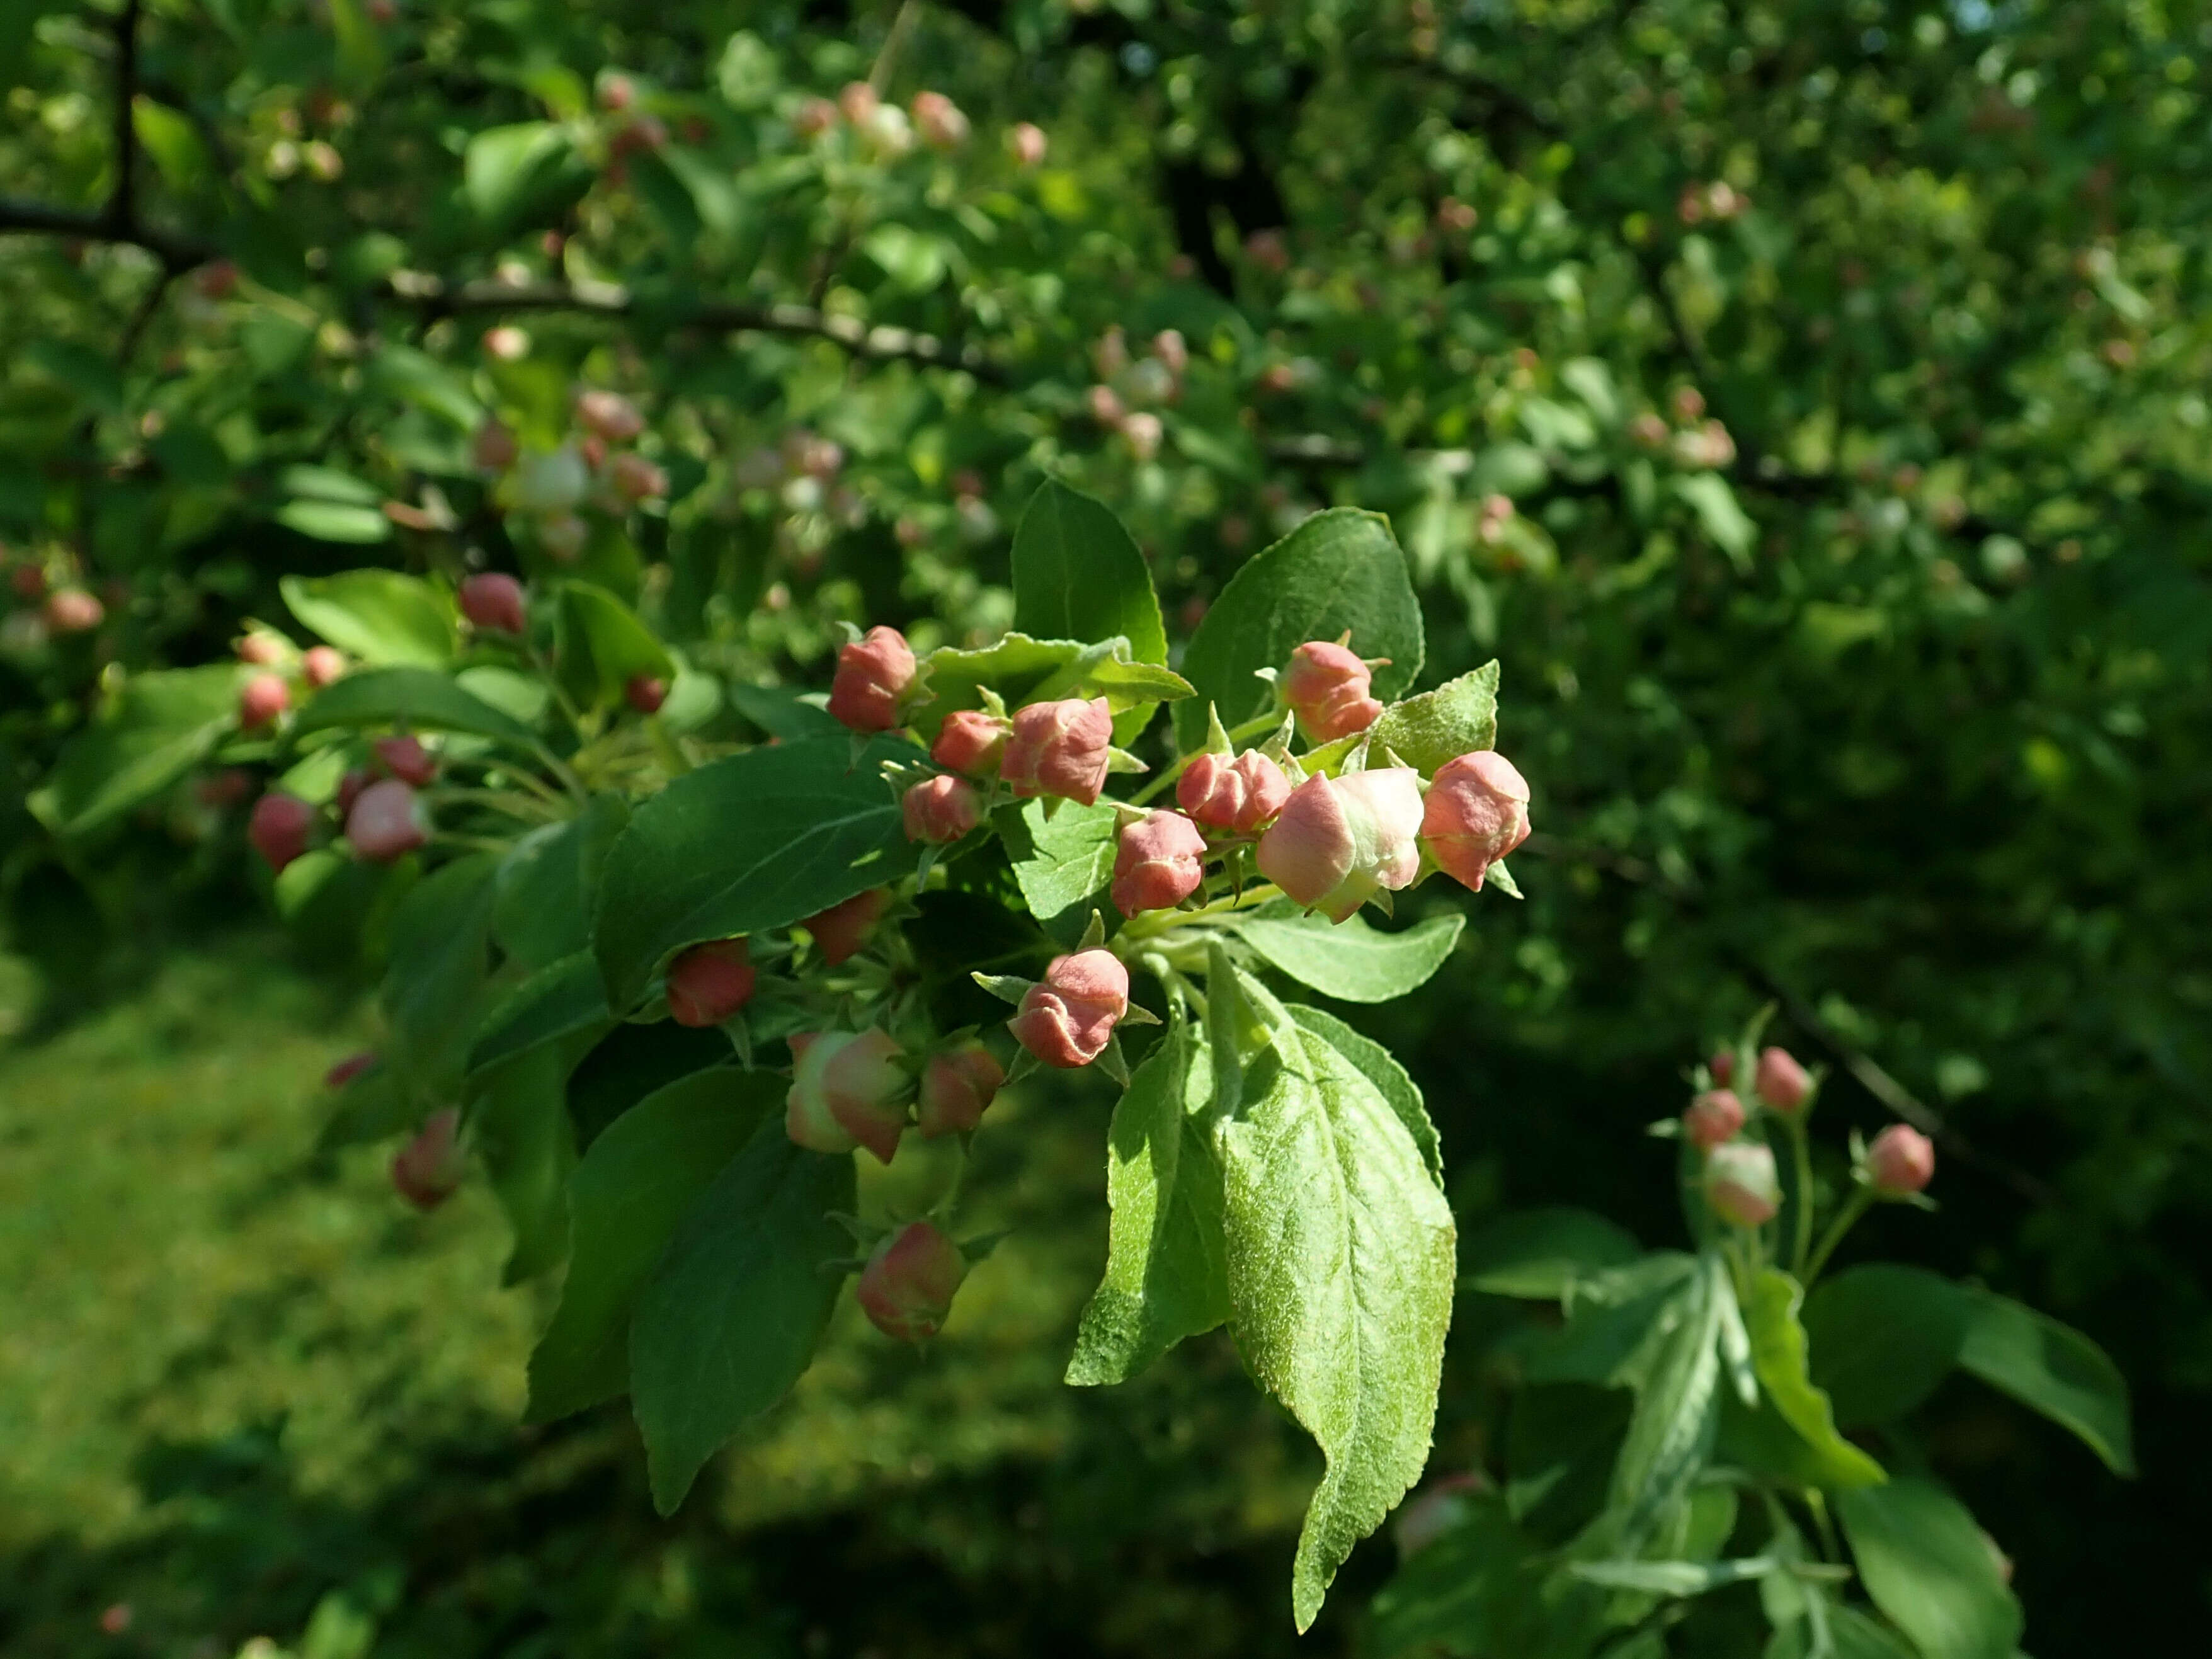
1013,478,1168,746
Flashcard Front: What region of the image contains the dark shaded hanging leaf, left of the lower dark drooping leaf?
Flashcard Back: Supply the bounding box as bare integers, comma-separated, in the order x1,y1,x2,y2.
527,1066,783,1422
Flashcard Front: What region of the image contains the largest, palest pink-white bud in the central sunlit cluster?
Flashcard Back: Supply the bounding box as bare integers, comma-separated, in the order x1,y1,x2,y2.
1258,765,1420,923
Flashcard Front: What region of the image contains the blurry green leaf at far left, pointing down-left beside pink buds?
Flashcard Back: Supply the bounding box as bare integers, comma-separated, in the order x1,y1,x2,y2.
31,664,241,836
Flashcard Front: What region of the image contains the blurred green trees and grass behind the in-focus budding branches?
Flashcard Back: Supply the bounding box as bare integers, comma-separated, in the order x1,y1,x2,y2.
0,0,2212,1659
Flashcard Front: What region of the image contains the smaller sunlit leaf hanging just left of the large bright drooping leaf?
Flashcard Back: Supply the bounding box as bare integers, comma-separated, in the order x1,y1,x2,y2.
1068,1024,1230,1387
